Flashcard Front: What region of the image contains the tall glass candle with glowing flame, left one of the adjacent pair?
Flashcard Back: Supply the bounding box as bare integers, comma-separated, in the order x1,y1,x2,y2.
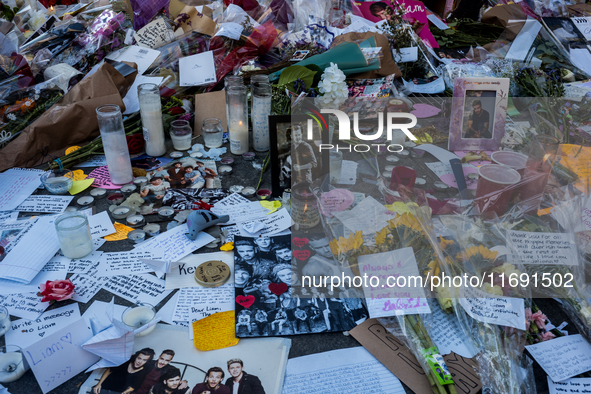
226,86,248,155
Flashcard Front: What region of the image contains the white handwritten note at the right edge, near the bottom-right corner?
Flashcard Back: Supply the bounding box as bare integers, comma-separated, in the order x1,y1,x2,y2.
526,334,591,382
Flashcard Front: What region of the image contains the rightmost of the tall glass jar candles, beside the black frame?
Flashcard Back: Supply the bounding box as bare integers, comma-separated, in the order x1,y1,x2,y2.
250,82,272,152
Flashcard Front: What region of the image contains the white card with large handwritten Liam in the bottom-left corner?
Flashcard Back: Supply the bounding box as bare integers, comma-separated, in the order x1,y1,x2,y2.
23,319,100,394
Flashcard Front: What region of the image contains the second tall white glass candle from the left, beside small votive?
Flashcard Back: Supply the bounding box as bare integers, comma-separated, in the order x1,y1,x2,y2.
137,83,166,157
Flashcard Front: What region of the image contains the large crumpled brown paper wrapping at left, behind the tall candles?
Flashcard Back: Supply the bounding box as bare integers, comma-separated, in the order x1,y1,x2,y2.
0,64,137,171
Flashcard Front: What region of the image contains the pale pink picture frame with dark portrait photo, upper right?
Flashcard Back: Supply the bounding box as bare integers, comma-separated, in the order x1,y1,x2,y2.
448,78,509,151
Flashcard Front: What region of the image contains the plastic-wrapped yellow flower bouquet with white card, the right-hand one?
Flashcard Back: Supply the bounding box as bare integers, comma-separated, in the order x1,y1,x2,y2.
430,216,535,394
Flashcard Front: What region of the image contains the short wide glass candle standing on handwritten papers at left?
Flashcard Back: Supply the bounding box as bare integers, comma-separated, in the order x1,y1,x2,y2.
55,212,92,259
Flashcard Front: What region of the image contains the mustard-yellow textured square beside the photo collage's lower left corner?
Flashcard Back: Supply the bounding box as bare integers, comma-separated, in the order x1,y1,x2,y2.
193,311,238,351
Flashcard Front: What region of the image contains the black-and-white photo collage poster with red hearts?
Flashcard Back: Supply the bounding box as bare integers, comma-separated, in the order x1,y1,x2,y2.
234,234,367,338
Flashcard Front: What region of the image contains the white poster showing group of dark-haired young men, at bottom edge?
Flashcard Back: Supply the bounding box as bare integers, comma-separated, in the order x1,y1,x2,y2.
78,325,289,394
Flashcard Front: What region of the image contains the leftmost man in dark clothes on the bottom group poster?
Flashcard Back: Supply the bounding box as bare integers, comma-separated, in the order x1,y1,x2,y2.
92,348,154,394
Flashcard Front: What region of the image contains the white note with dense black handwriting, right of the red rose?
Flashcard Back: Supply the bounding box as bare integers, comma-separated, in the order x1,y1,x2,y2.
103,274,170,305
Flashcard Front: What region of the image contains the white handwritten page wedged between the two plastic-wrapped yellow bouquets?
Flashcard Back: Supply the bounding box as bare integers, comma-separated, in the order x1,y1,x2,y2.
428,300,477,358
